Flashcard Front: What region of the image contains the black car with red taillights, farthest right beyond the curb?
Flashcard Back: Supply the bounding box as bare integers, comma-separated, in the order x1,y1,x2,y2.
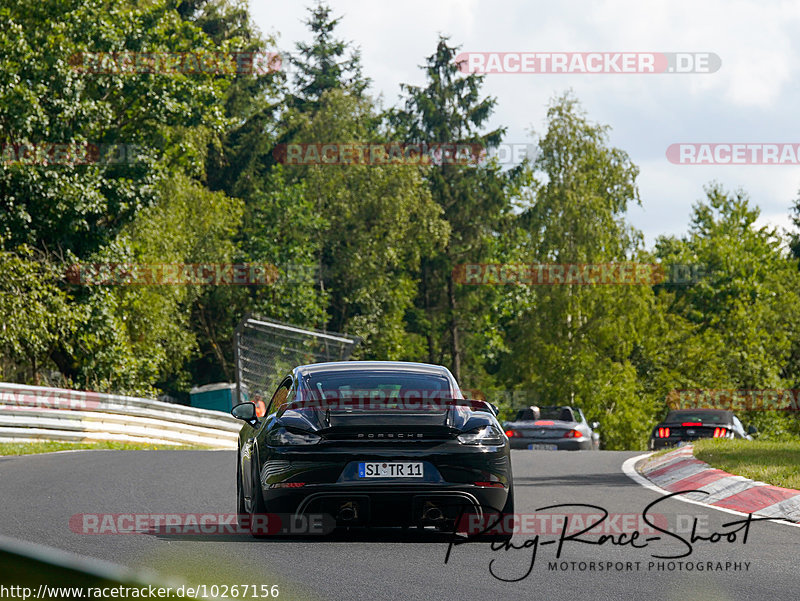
650,409,758,451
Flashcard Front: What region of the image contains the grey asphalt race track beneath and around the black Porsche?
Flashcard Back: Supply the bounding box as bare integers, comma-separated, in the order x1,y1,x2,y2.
0,451,800,601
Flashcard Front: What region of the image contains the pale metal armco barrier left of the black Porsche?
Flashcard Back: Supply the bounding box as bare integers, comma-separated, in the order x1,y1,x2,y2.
0,383,242,449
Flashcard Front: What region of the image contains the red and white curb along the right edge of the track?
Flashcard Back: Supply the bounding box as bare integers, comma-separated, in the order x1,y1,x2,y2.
623,445,800,523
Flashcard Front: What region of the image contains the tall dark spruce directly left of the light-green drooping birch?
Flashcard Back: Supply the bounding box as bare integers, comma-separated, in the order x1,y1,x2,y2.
389,37,512,386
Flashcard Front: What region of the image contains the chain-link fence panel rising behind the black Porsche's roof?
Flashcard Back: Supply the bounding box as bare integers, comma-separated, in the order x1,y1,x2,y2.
234,316,361,405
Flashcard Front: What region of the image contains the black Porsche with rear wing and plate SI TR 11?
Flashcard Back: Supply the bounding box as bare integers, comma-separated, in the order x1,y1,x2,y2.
231,361,514,540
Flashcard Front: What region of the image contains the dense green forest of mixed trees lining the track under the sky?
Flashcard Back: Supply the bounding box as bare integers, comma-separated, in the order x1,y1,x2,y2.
0,0,800,448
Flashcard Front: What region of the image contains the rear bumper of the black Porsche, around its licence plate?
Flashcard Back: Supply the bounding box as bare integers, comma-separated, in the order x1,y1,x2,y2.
261,442,512,526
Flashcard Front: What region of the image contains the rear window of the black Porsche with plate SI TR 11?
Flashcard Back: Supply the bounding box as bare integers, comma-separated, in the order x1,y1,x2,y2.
304,372,453,399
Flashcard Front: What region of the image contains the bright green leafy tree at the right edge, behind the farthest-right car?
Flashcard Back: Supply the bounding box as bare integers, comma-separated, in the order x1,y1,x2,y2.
652,184,800,437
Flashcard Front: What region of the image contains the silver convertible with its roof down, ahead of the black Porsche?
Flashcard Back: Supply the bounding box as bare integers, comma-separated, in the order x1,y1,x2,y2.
503,406,600,451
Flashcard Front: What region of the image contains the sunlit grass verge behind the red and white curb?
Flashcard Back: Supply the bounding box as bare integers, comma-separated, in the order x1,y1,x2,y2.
693,438,800,489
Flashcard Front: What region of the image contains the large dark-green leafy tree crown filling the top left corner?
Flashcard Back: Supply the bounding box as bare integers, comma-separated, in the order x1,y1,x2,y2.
0,0,233,257
